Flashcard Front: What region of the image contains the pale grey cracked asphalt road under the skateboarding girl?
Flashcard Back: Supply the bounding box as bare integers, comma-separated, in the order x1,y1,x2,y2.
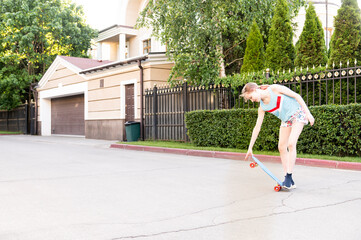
0,136,361,240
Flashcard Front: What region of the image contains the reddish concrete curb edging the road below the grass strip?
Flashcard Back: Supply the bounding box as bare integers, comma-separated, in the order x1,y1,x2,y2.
110,144,361,171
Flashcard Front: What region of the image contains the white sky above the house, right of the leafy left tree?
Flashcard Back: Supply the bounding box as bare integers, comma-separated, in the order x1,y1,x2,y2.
72,0,361,30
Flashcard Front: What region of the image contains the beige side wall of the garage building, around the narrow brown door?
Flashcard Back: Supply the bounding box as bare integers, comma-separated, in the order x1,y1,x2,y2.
85,62,172,140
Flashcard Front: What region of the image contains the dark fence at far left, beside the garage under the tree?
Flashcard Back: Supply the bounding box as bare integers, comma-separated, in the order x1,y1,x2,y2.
0,103,36,134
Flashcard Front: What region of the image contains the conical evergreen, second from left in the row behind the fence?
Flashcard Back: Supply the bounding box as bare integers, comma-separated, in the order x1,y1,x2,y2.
266,0,295,70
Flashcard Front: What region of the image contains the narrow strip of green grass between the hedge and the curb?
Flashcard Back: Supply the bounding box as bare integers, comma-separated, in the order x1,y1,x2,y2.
118,141,361,162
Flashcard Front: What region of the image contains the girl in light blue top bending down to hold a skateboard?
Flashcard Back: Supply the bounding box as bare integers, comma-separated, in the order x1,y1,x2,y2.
241,83,315,189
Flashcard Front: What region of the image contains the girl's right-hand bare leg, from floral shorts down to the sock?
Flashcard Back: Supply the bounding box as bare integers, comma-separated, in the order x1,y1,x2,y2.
287,122,305,173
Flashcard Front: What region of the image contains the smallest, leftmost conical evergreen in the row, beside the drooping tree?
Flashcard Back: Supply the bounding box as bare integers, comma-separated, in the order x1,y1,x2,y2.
241,21,265,73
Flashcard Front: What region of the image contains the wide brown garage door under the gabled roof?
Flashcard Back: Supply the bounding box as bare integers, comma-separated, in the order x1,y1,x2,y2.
51,95,85,135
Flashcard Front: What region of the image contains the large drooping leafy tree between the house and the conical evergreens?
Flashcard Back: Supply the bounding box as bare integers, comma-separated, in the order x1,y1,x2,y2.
137,0,303,85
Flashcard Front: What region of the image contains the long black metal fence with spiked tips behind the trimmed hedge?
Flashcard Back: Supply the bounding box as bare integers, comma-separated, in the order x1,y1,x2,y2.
144,67,361,141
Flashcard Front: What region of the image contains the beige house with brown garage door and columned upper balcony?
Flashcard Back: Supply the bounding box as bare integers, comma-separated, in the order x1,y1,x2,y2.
37,0,173,140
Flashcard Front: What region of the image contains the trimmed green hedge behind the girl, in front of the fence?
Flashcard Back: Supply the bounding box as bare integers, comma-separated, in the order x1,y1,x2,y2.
185,104,361,157
